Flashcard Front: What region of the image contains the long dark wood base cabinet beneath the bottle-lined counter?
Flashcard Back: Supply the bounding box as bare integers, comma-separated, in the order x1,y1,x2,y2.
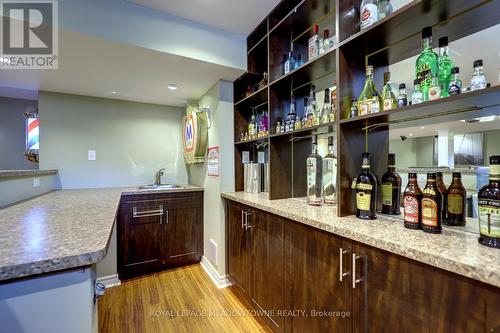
226,200,500,333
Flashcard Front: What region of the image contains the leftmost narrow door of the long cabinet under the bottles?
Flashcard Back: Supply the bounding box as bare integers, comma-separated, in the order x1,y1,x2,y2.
226,201,250,294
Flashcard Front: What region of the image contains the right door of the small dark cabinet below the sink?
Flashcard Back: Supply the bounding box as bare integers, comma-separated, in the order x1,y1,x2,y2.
163,196,203,266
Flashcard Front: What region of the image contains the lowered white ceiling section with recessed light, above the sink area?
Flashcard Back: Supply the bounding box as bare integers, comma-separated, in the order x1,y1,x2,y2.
0,32,241,106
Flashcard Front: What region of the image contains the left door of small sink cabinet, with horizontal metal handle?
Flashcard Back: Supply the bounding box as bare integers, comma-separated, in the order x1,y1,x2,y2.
117,201,165,279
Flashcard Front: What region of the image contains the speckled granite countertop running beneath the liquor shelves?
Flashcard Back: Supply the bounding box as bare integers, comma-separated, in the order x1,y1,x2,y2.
222,192,500,287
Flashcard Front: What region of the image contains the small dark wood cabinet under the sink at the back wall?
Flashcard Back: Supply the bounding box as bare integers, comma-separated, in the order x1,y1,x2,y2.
117,192,203,280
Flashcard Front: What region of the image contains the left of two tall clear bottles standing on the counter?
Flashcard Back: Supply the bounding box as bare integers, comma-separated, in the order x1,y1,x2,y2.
306,136,325,206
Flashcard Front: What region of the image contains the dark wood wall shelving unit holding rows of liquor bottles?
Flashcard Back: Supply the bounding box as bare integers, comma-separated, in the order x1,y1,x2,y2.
235,0,500,216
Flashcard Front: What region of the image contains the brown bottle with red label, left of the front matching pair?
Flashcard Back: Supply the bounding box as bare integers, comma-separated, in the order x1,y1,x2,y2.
403,173,422,229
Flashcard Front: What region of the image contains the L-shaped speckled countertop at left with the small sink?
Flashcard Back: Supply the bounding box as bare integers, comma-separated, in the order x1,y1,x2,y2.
0,185,203,281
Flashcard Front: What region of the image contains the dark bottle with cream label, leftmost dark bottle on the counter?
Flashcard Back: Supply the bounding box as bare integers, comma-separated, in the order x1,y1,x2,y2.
355,153,377,220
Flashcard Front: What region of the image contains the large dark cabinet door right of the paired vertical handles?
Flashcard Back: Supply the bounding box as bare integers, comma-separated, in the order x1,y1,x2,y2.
353,243,485,333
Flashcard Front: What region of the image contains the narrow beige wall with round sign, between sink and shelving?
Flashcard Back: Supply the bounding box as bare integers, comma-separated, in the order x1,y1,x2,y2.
189,81,234,276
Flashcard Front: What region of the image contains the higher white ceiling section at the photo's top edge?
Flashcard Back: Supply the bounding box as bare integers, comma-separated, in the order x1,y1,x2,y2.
128,0,280,37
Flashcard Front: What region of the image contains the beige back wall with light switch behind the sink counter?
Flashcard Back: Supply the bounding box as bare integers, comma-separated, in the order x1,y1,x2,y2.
39,92,188,188
